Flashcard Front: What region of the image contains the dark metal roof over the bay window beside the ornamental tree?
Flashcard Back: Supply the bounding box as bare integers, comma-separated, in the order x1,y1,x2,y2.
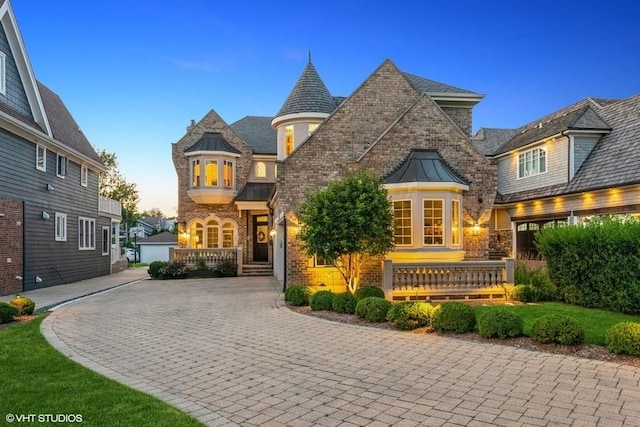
384,150,469,185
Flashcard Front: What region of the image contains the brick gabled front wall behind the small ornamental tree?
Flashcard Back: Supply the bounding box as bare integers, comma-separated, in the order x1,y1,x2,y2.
275,61,497,285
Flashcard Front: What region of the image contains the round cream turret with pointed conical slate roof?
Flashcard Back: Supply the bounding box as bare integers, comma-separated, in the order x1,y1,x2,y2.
271,55,339,160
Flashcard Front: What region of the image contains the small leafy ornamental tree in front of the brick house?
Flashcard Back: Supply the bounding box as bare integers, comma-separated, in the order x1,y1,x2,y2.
298,171,394,293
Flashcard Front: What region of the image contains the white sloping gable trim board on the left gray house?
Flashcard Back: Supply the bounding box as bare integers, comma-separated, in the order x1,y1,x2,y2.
0,0,53,138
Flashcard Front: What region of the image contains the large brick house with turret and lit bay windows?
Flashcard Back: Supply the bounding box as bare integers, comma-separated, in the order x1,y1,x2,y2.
172,60,504,296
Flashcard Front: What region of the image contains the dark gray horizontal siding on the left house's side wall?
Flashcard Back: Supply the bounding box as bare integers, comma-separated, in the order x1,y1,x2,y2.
0,129,111,290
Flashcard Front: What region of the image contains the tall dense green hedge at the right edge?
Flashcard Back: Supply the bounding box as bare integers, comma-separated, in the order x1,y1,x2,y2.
536,218,640,314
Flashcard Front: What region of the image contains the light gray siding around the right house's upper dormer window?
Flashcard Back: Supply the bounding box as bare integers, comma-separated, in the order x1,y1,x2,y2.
498,137,569,194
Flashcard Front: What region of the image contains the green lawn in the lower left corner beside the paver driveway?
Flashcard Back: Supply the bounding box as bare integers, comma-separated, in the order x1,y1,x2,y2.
0,317,202,426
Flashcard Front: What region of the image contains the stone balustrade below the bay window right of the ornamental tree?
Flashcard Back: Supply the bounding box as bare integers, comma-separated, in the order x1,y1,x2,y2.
383,258,515,300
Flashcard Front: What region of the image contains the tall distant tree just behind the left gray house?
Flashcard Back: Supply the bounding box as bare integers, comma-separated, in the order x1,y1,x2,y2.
96,150,140,222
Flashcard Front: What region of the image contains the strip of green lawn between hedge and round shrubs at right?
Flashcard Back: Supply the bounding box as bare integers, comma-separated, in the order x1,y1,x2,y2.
474,302,640,346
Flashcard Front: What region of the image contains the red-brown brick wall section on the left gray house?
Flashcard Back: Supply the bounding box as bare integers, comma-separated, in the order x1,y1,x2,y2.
0,198,24,295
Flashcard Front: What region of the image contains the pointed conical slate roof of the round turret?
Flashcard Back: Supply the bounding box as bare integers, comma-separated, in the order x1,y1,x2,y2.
276,61,337,117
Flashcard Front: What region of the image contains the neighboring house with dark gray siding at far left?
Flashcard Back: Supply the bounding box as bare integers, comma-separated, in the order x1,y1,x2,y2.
0,0,120,295
